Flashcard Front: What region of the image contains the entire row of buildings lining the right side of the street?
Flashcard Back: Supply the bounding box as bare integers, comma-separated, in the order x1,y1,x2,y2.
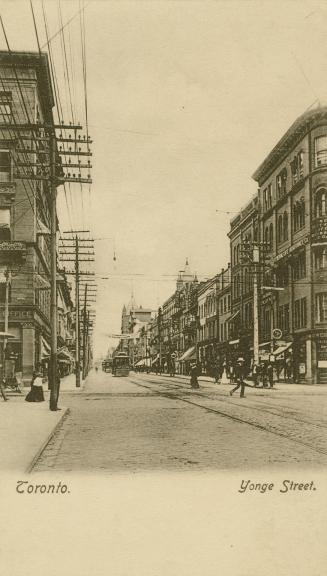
123,107,327,383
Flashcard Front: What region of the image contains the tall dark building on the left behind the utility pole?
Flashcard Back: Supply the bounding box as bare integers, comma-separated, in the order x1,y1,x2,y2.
0,52,54,378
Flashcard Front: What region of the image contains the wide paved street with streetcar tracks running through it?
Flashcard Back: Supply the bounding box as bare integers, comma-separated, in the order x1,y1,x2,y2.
34,373,327,473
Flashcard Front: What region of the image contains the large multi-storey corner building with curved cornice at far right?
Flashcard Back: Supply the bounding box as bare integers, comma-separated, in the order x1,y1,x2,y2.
253,107,327,384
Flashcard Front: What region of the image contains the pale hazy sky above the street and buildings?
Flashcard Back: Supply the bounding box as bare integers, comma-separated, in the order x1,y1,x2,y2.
0,0,327,355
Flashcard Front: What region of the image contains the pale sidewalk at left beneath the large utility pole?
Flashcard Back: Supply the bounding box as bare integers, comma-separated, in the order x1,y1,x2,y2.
0,374,78,473
